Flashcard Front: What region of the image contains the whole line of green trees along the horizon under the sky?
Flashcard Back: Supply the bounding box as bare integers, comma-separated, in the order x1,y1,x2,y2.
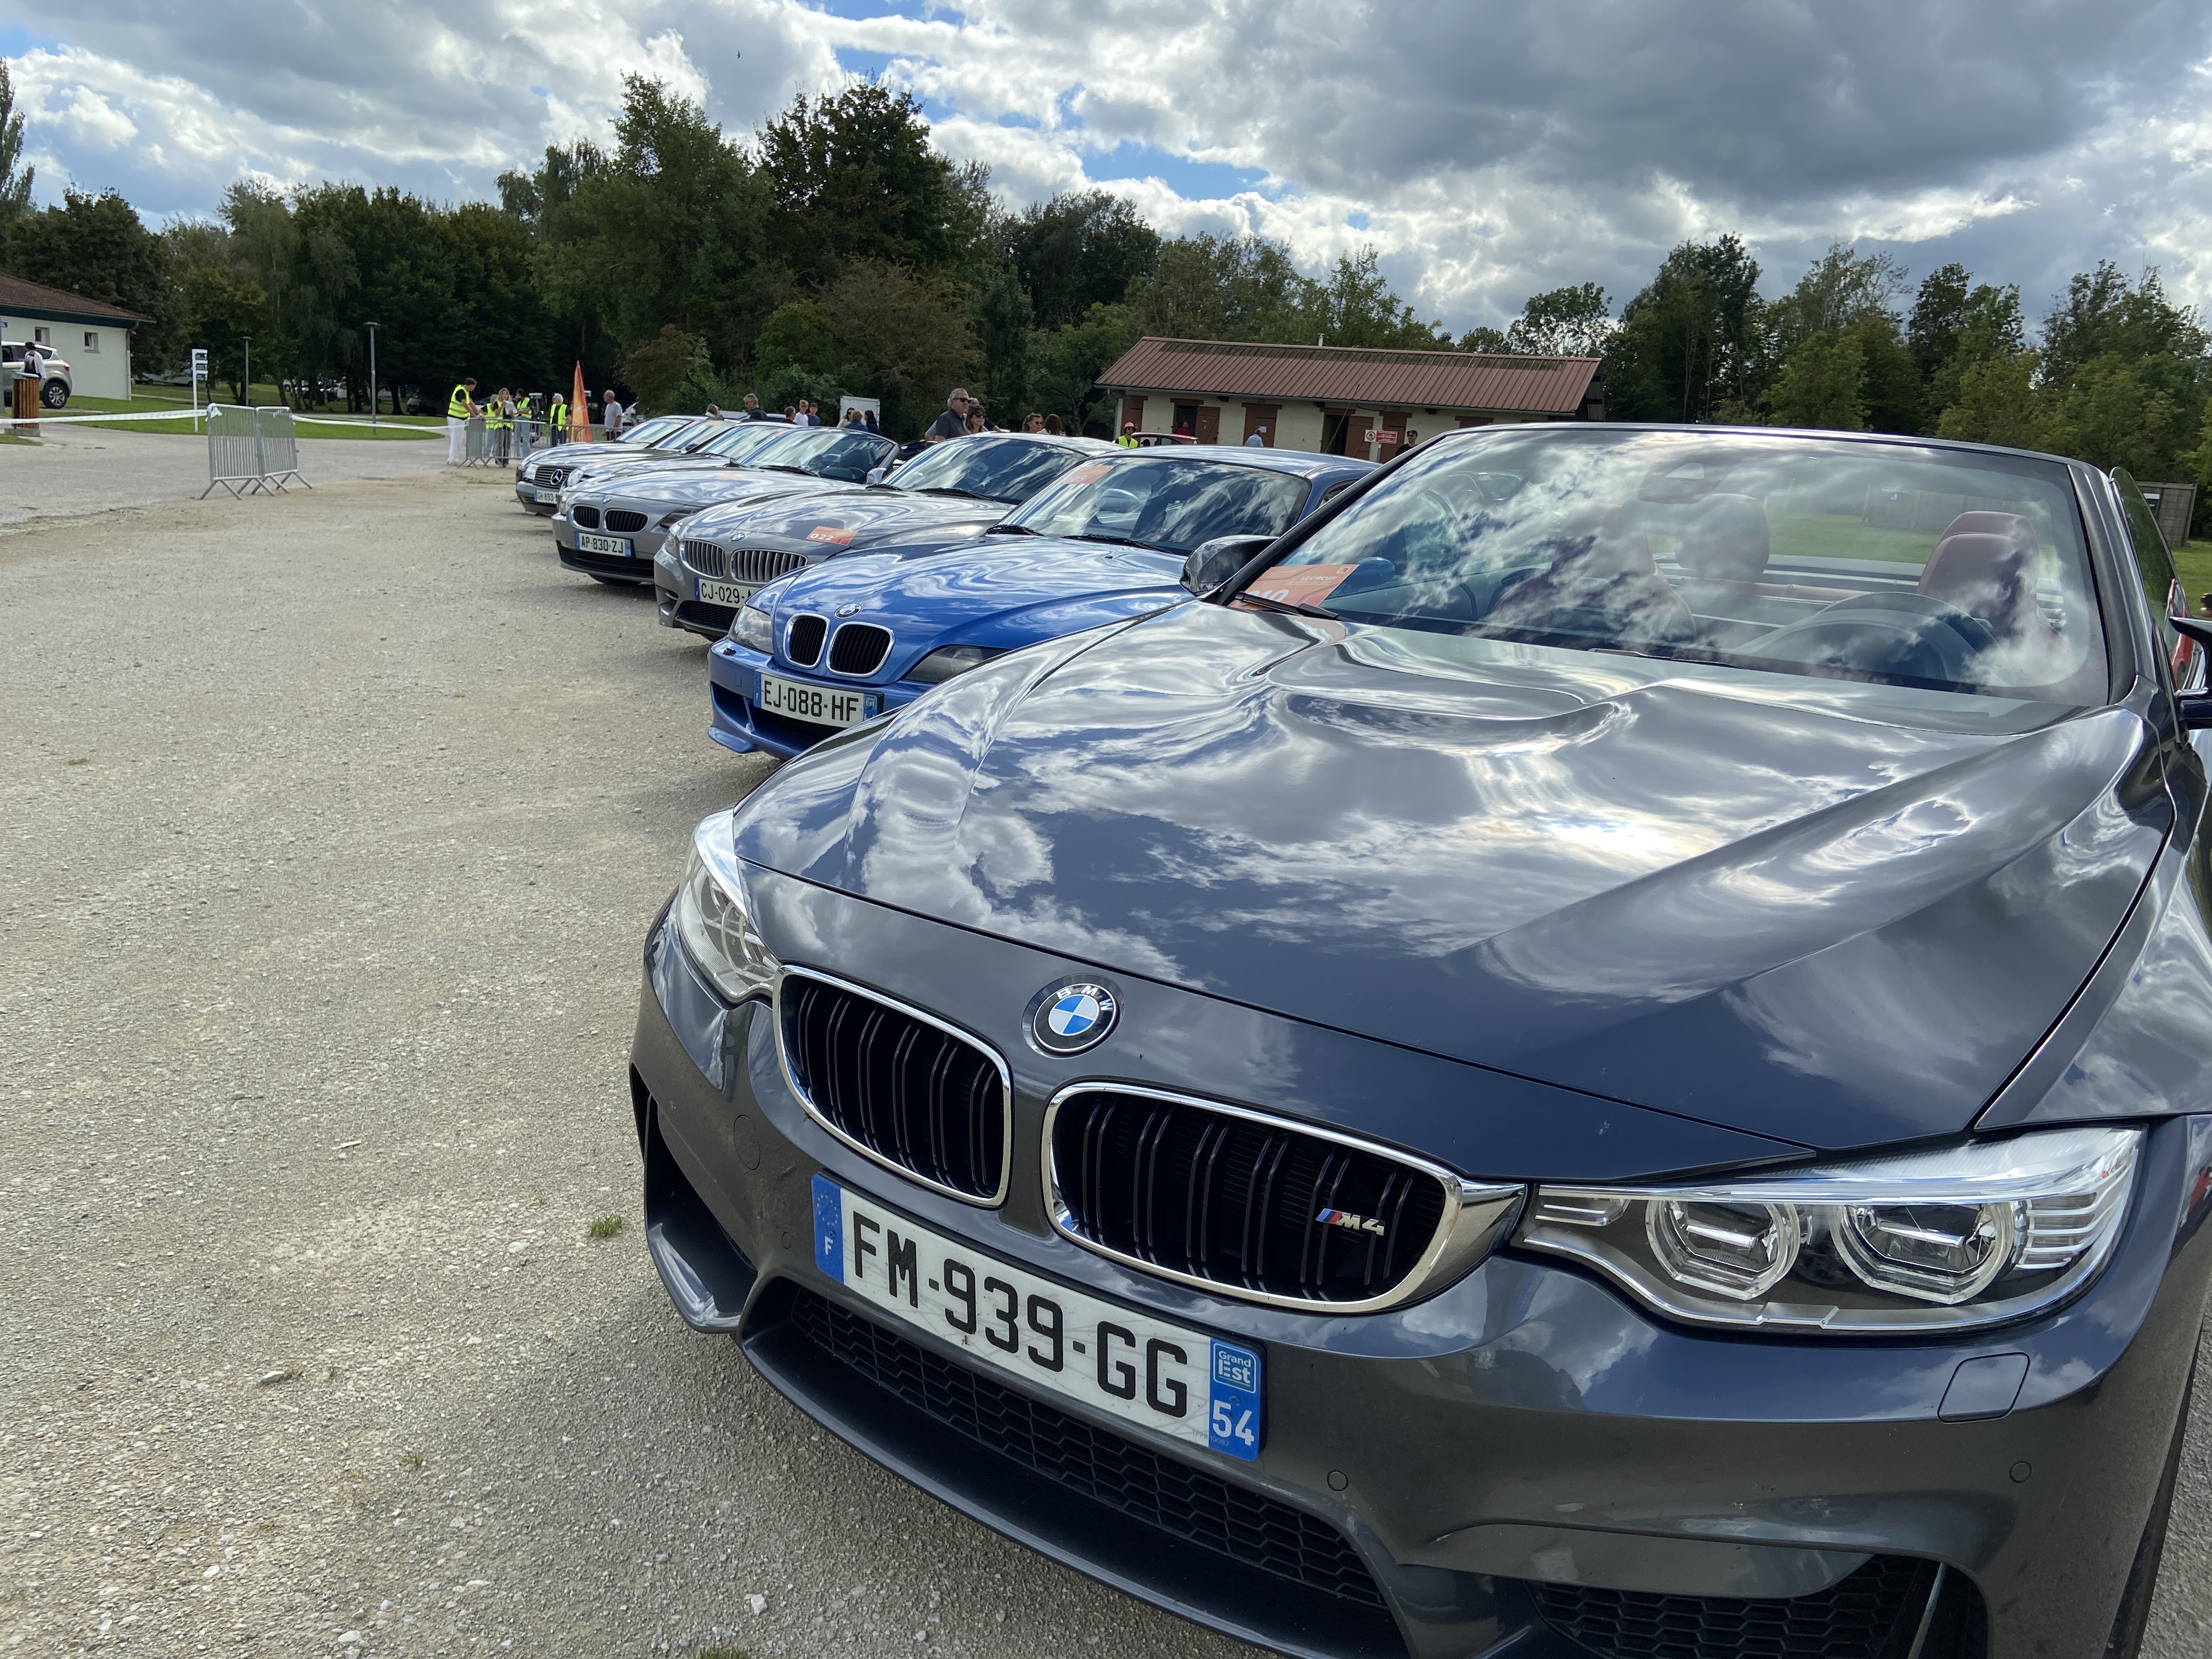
0,62,2212,520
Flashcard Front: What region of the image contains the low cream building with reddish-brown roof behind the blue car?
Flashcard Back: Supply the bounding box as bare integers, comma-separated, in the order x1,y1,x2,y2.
1097,336,1606,460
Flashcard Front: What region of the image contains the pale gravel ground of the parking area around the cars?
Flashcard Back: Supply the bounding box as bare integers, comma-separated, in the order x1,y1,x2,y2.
0,469,2212,1659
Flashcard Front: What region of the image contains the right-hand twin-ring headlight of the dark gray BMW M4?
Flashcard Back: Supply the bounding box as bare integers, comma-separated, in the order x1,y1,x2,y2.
1515,1128,2143,1334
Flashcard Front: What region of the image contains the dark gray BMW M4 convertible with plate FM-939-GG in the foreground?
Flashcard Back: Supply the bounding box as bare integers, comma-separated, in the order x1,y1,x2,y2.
630,425,2212,1659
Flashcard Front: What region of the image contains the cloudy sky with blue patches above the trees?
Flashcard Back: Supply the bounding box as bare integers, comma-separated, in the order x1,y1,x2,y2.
0,0,2212,330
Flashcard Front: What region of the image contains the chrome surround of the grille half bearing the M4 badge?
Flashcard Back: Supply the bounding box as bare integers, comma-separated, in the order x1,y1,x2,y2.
1040,1082,1528,1314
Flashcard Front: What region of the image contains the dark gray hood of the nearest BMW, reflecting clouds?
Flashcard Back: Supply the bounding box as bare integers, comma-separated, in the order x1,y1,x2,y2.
737,606,2165,1148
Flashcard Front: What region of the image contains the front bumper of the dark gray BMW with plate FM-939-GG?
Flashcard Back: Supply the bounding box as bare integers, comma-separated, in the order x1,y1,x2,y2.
630,876,2212,1659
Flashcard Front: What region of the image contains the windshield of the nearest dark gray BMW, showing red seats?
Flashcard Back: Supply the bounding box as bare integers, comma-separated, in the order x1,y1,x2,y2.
1248,429,2106,703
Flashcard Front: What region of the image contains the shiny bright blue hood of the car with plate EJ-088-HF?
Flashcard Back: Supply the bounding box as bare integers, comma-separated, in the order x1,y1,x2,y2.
776,535,1190,668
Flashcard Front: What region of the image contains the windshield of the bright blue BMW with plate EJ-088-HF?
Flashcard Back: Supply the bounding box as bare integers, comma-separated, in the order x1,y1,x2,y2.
1009,452,1310,553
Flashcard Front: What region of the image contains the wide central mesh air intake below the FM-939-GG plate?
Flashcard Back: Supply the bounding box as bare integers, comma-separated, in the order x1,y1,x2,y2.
792,1290,1383,1608
